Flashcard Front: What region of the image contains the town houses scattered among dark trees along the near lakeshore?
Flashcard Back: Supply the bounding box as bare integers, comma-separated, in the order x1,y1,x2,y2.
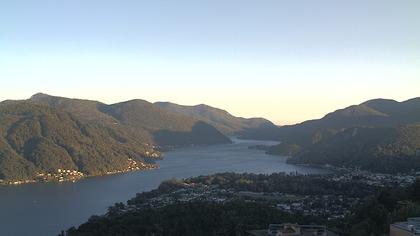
111,171,420,224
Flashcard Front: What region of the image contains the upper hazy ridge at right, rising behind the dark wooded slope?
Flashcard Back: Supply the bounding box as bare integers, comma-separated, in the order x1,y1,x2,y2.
271,98,420,145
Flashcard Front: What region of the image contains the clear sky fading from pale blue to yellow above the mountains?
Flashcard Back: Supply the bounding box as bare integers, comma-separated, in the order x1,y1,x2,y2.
0,0,420,124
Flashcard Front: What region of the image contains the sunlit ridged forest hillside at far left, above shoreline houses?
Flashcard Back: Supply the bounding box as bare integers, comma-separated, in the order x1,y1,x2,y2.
0,101,153,180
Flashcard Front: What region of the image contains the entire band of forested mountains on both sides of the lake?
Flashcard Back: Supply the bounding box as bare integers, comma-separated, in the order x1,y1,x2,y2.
0,94,420,182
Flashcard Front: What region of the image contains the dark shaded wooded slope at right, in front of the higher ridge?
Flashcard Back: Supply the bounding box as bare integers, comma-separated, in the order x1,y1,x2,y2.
289,125,420,173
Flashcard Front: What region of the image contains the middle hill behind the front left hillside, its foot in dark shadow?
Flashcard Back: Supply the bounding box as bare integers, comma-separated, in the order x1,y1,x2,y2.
102,100,231,146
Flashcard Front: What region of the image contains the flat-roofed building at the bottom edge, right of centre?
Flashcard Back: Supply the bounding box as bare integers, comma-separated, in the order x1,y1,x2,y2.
248,223,337,236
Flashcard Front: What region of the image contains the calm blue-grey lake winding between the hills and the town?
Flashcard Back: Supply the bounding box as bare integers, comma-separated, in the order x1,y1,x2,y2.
0,140,325,236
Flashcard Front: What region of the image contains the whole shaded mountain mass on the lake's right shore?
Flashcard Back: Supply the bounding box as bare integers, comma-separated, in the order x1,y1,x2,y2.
267,98,420,172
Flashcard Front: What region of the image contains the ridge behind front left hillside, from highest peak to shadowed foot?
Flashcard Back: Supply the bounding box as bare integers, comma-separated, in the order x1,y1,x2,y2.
31,94,230,146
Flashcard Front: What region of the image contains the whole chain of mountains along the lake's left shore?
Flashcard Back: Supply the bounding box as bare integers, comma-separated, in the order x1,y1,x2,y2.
0,93,275,181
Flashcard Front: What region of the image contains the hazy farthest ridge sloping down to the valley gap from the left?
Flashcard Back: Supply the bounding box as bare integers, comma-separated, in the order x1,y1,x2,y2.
155,102,276,136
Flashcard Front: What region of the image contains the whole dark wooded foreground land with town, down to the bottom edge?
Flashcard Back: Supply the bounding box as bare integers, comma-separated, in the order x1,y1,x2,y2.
64,171,420,236
